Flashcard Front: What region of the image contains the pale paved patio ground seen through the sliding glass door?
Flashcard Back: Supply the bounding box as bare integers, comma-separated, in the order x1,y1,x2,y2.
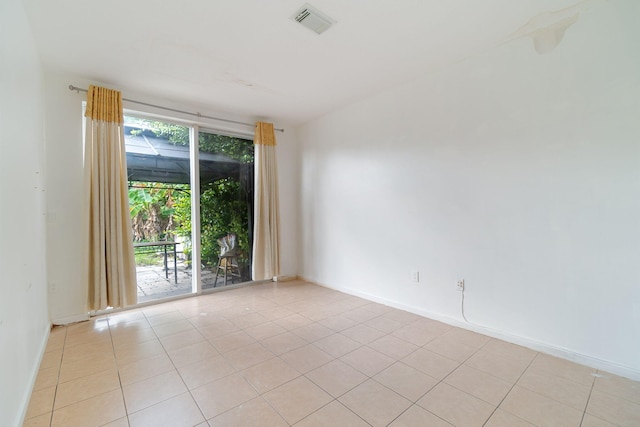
136,258,246,303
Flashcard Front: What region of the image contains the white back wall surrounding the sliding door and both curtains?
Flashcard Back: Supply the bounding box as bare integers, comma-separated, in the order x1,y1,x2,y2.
45,71,298,323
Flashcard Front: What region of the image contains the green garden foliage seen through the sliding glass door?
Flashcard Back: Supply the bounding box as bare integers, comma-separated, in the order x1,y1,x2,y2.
125,117,254,280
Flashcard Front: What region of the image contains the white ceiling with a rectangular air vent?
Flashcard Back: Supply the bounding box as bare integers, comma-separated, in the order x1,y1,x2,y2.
24,0,584,125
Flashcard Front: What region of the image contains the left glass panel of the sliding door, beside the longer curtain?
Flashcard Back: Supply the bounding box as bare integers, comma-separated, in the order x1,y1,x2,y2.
124,116,192,302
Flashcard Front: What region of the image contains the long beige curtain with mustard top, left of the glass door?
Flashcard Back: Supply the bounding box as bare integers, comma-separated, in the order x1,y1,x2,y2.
84,86,137,310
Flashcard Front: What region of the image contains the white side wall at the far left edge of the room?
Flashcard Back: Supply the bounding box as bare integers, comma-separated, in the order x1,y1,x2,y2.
0,0,50,426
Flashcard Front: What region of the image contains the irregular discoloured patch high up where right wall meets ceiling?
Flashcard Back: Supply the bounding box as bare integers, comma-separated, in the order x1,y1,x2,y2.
507,0,591,54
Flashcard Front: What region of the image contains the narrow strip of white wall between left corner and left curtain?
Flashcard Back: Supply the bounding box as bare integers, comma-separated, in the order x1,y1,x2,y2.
45,72,88,324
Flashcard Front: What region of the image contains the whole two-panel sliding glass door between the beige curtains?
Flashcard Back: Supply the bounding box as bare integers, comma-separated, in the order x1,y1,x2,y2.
125,116,253,302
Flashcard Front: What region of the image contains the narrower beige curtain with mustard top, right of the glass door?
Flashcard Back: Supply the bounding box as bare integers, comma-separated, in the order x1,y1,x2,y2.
252,122,280,280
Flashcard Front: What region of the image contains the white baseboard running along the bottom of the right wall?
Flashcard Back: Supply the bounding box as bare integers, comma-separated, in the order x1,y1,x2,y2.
300,277,640,381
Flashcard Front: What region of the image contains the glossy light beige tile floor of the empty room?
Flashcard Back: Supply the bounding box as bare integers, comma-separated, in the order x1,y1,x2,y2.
24,281,640,427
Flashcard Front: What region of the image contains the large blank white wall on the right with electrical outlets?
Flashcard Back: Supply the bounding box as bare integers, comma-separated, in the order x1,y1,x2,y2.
298,1,640,378
